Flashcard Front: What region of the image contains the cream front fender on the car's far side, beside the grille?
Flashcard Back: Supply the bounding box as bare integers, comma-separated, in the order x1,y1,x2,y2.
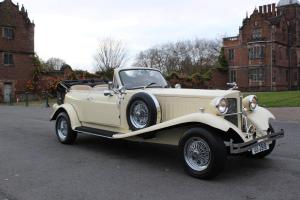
247,106,275,131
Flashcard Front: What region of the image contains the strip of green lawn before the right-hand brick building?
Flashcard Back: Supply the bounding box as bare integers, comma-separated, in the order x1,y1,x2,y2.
244,91,300,107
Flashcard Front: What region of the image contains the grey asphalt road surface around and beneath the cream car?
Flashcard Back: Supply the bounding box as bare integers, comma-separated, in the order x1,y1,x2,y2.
0,106,300,200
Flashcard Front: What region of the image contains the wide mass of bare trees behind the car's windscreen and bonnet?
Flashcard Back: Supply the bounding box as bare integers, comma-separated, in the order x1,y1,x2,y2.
135,39,221,74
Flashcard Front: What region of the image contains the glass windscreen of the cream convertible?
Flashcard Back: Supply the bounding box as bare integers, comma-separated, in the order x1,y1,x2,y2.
119,69,168,89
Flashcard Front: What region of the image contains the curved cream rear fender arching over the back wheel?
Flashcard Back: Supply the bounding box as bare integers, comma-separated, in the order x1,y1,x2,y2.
50,104,81,130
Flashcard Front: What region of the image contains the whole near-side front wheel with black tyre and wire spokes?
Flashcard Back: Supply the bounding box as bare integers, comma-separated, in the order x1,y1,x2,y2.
179,128,227,179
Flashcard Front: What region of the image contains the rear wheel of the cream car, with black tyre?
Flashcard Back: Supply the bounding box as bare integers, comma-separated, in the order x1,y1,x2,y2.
55,112,77,144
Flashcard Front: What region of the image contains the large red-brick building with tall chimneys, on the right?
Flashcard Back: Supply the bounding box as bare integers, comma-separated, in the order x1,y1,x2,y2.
223,0,300,91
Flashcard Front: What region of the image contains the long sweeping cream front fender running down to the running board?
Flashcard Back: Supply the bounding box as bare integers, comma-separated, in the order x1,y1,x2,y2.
113,113,240,139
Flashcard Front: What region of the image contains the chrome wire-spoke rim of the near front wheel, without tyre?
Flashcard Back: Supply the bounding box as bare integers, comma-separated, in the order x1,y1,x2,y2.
184,137,211,171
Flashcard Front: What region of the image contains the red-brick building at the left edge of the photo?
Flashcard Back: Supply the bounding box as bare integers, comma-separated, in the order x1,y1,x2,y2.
0,0,35,102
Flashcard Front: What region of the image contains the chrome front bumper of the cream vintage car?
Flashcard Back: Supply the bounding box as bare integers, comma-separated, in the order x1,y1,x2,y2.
226,129,284,154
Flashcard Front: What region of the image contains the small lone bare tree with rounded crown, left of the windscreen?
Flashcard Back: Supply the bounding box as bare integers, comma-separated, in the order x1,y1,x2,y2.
95,38,127,71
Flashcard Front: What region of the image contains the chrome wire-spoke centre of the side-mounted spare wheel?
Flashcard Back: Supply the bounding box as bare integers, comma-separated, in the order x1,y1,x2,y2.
130,101,149,129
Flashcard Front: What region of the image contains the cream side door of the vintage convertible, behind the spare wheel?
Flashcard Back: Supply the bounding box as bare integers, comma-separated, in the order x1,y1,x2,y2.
85,91,121,127
